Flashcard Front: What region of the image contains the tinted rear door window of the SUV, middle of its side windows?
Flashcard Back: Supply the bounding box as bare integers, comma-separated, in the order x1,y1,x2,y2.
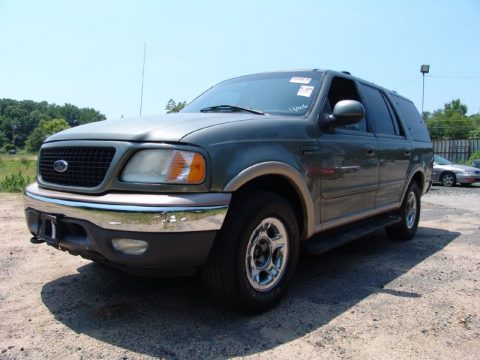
359,84,399,135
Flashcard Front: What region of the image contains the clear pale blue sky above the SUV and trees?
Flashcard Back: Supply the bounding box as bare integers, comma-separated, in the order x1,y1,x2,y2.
0,0,480,118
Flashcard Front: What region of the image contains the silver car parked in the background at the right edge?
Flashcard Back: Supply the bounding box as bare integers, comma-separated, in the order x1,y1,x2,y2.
432,155,480,187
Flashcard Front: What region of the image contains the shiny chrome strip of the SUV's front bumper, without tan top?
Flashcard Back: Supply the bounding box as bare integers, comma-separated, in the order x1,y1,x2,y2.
24,188,230,233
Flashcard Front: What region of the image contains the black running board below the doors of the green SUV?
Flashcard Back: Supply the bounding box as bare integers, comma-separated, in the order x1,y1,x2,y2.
302,215,401,255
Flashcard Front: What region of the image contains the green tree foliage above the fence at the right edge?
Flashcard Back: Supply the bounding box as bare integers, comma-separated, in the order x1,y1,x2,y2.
424,99,480,139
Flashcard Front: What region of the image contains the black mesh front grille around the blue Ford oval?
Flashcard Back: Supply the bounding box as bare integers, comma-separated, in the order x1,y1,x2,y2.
39,147,115,187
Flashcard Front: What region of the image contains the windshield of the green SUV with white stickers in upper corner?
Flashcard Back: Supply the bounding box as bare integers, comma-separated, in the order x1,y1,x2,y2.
182,71,322,116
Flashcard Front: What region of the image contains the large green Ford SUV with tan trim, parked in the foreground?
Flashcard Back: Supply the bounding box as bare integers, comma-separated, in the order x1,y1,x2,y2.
25,70,433,312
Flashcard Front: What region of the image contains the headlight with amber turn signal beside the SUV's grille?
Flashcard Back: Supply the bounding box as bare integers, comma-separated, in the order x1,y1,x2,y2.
120,149,205,184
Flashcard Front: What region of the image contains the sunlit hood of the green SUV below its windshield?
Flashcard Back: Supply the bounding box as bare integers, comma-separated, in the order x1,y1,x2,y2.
46,113,271,142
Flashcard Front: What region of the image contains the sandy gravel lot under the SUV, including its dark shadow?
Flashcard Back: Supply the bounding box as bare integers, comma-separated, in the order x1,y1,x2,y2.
0,187,480,360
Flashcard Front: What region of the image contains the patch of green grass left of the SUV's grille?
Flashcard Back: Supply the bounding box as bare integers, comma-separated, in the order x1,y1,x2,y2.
0,154,37,192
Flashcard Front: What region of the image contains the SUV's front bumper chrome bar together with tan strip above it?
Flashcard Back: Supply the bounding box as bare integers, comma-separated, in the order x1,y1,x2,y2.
24,183,231,233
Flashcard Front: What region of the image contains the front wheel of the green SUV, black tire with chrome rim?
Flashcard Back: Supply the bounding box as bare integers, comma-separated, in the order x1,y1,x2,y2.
202,191,299,313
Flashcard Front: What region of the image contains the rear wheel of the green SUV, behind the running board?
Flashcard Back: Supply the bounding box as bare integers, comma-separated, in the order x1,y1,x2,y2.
385,182,420,241
